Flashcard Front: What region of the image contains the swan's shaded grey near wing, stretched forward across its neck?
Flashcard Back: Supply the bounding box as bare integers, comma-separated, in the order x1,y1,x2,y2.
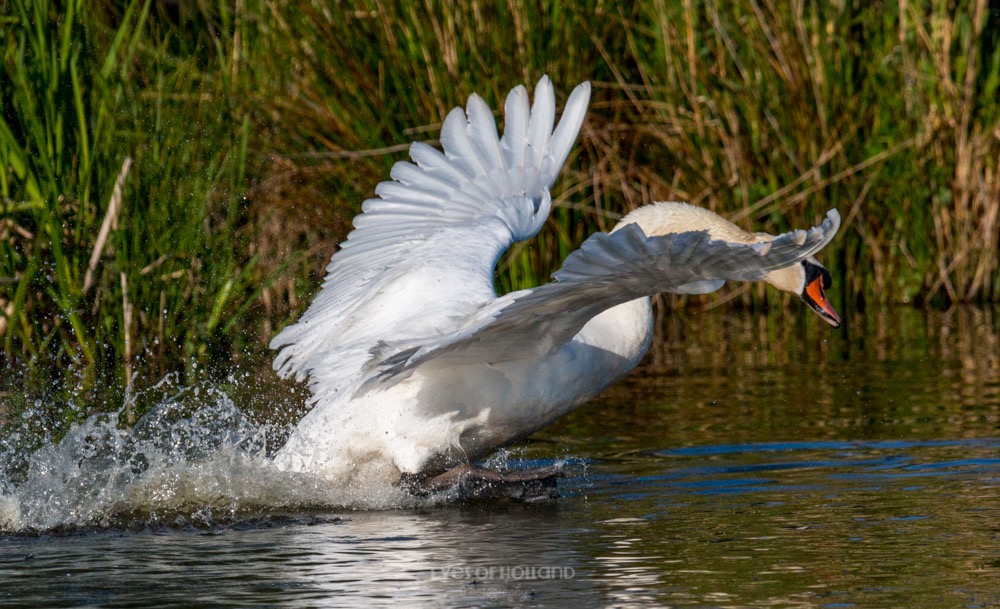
371,210,840,381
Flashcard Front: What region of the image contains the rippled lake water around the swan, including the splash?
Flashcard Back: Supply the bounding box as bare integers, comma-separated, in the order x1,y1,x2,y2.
0,309,1000,607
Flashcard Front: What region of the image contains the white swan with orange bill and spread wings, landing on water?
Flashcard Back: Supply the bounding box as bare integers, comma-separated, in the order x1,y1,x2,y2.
270,76,840,488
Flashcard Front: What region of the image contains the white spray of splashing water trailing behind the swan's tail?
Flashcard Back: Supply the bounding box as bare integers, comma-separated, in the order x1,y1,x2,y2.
0,379,426,532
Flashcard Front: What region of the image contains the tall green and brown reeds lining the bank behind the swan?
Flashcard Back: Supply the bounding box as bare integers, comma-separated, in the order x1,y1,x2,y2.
0,0,1000,423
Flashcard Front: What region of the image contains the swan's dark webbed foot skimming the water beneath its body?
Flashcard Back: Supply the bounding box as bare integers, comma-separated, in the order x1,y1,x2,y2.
399,463,565,502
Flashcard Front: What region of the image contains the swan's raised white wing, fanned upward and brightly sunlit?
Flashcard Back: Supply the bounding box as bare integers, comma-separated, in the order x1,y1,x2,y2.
271,77,590,397
